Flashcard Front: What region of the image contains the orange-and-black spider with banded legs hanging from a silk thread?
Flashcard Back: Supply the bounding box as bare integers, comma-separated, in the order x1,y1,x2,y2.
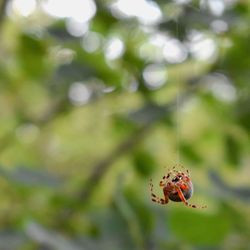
150,166,206,208
